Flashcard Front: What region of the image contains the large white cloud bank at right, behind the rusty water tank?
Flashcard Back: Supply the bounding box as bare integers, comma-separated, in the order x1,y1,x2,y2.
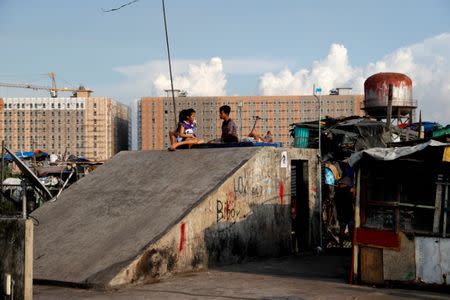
259,33,450,124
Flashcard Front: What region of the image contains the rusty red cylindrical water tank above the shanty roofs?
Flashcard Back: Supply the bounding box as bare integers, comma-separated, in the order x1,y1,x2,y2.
364,73,417,118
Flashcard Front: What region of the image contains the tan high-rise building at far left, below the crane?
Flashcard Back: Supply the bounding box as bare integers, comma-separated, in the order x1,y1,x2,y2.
0,97,130,160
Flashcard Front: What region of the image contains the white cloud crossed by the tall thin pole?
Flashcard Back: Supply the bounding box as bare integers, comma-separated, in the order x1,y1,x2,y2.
109,58,288,98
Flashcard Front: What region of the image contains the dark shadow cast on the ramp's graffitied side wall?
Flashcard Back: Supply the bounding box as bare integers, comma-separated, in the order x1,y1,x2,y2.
201,201,291,268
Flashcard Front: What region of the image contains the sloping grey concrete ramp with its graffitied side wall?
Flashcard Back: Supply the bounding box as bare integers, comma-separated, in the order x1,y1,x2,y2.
33,148,314,288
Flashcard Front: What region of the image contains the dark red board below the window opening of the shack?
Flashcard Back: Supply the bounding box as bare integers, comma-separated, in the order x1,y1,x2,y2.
356,228,400,249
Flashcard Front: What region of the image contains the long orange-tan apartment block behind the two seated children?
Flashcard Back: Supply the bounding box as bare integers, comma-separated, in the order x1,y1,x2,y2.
137,89,364,150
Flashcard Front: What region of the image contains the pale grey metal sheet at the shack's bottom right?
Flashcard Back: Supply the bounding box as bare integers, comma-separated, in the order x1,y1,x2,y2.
415,237,450,285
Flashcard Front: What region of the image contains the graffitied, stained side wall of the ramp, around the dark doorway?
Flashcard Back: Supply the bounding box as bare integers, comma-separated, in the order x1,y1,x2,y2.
109,148,318,287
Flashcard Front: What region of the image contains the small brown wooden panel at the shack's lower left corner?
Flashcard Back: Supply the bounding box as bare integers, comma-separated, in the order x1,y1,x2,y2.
361,247,384,284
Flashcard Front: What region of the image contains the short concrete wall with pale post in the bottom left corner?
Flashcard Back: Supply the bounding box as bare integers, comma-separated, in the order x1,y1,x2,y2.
0,219,33,300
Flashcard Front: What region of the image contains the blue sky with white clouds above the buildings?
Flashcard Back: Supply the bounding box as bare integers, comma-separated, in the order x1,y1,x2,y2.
0,0,450,122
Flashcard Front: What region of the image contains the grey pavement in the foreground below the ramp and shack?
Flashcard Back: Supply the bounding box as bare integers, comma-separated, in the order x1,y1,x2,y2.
34,254,450,300
